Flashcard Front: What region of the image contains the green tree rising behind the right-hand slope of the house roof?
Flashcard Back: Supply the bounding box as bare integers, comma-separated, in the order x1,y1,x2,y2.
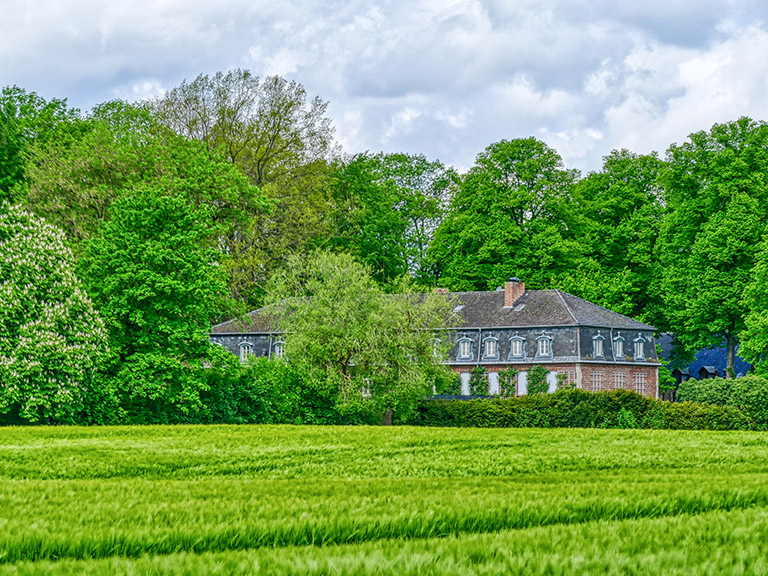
559,150,664,325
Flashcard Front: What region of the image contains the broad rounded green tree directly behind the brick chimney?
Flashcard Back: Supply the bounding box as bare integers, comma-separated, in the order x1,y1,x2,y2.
429,138,580,290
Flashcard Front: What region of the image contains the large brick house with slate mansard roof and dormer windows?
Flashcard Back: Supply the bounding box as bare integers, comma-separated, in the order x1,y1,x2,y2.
211,278,659,397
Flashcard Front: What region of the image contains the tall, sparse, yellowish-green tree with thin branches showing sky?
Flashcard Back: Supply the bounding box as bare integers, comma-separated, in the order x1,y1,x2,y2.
151,69,337,304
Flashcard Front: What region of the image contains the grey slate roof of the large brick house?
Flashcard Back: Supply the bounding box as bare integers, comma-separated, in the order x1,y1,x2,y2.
212,290,655,334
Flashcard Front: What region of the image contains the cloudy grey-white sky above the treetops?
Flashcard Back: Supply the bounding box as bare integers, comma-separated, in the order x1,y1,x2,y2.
0,0,768,174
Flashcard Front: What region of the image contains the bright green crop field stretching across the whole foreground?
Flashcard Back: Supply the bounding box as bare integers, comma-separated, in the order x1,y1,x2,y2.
0,426,768,576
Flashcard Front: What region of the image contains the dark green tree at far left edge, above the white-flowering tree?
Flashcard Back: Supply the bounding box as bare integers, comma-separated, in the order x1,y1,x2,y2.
0,86,77,201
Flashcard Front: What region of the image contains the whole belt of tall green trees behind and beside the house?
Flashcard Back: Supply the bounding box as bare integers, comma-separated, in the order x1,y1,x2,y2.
0,70,768,421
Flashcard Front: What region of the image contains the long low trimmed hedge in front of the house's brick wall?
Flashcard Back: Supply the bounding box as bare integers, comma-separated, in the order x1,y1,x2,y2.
408,390,757,430
